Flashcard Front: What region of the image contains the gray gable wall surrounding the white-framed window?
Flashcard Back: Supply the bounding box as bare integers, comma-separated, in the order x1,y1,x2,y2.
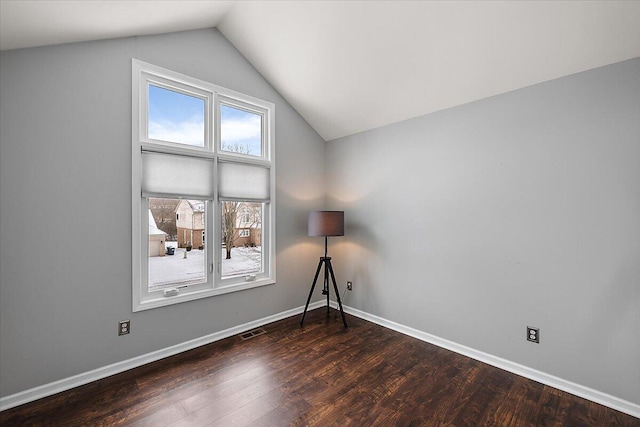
0,29,325,396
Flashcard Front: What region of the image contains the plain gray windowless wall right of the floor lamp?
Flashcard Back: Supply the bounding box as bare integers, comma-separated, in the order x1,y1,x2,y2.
327,59,640,404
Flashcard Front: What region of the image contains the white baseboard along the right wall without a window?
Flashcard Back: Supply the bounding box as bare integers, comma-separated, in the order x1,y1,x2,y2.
331,301,640,418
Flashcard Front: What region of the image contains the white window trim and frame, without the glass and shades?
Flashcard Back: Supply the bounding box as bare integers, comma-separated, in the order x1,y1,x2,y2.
131,59,276,312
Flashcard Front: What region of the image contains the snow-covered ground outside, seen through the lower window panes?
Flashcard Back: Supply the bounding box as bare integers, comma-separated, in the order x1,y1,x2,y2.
149,242,262,290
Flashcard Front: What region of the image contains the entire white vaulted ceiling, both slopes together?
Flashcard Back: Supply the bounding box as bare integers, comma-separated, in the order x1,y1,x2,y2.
0,0,640,140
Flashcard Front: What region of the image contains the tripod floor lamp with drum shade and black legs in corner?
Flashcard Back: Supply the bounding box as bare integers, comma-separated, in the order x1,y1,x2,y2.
300,211,347,328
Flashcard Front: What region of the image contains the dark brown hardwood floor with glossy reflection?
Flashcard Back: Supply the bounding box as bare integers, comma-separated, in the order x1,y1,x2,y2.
0,308,640,427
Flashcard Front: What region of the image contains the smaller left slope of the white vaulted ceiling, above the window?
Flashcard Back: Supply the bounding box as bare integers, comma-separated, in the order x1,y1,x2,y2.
0,0,235,50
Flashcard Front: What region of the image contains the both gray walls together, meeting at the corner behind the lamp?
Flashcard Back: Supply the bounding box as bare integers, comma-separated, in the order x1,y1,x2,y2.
0,26,640,403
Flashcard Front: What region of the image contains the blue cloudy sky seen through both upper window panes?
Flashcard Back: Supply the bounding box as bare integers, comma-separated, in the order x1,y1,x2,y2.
148,85,262,156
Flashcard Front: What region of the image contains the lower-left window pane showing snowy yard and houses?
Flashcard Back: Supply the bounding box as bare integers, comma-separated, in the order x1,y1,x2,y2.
148,198,207,291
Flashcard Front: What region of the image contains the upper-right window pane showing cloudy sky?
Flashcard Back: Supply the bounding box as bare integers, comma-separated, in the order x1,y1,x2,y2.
220,104,262,157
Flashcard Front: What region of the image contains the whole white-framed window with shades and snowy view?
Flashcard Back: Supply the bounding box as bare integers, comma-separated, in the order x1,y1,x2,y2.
132,60,275,311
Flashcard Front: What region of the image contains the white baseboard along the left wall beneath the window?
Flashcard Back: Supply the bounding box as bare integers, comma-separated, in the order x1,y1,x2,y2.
0,300,326,411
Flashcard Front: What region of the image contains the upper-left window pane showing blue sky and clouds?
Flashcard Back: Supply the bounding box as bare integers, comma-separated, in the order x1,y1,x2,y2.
148,85,205,147
